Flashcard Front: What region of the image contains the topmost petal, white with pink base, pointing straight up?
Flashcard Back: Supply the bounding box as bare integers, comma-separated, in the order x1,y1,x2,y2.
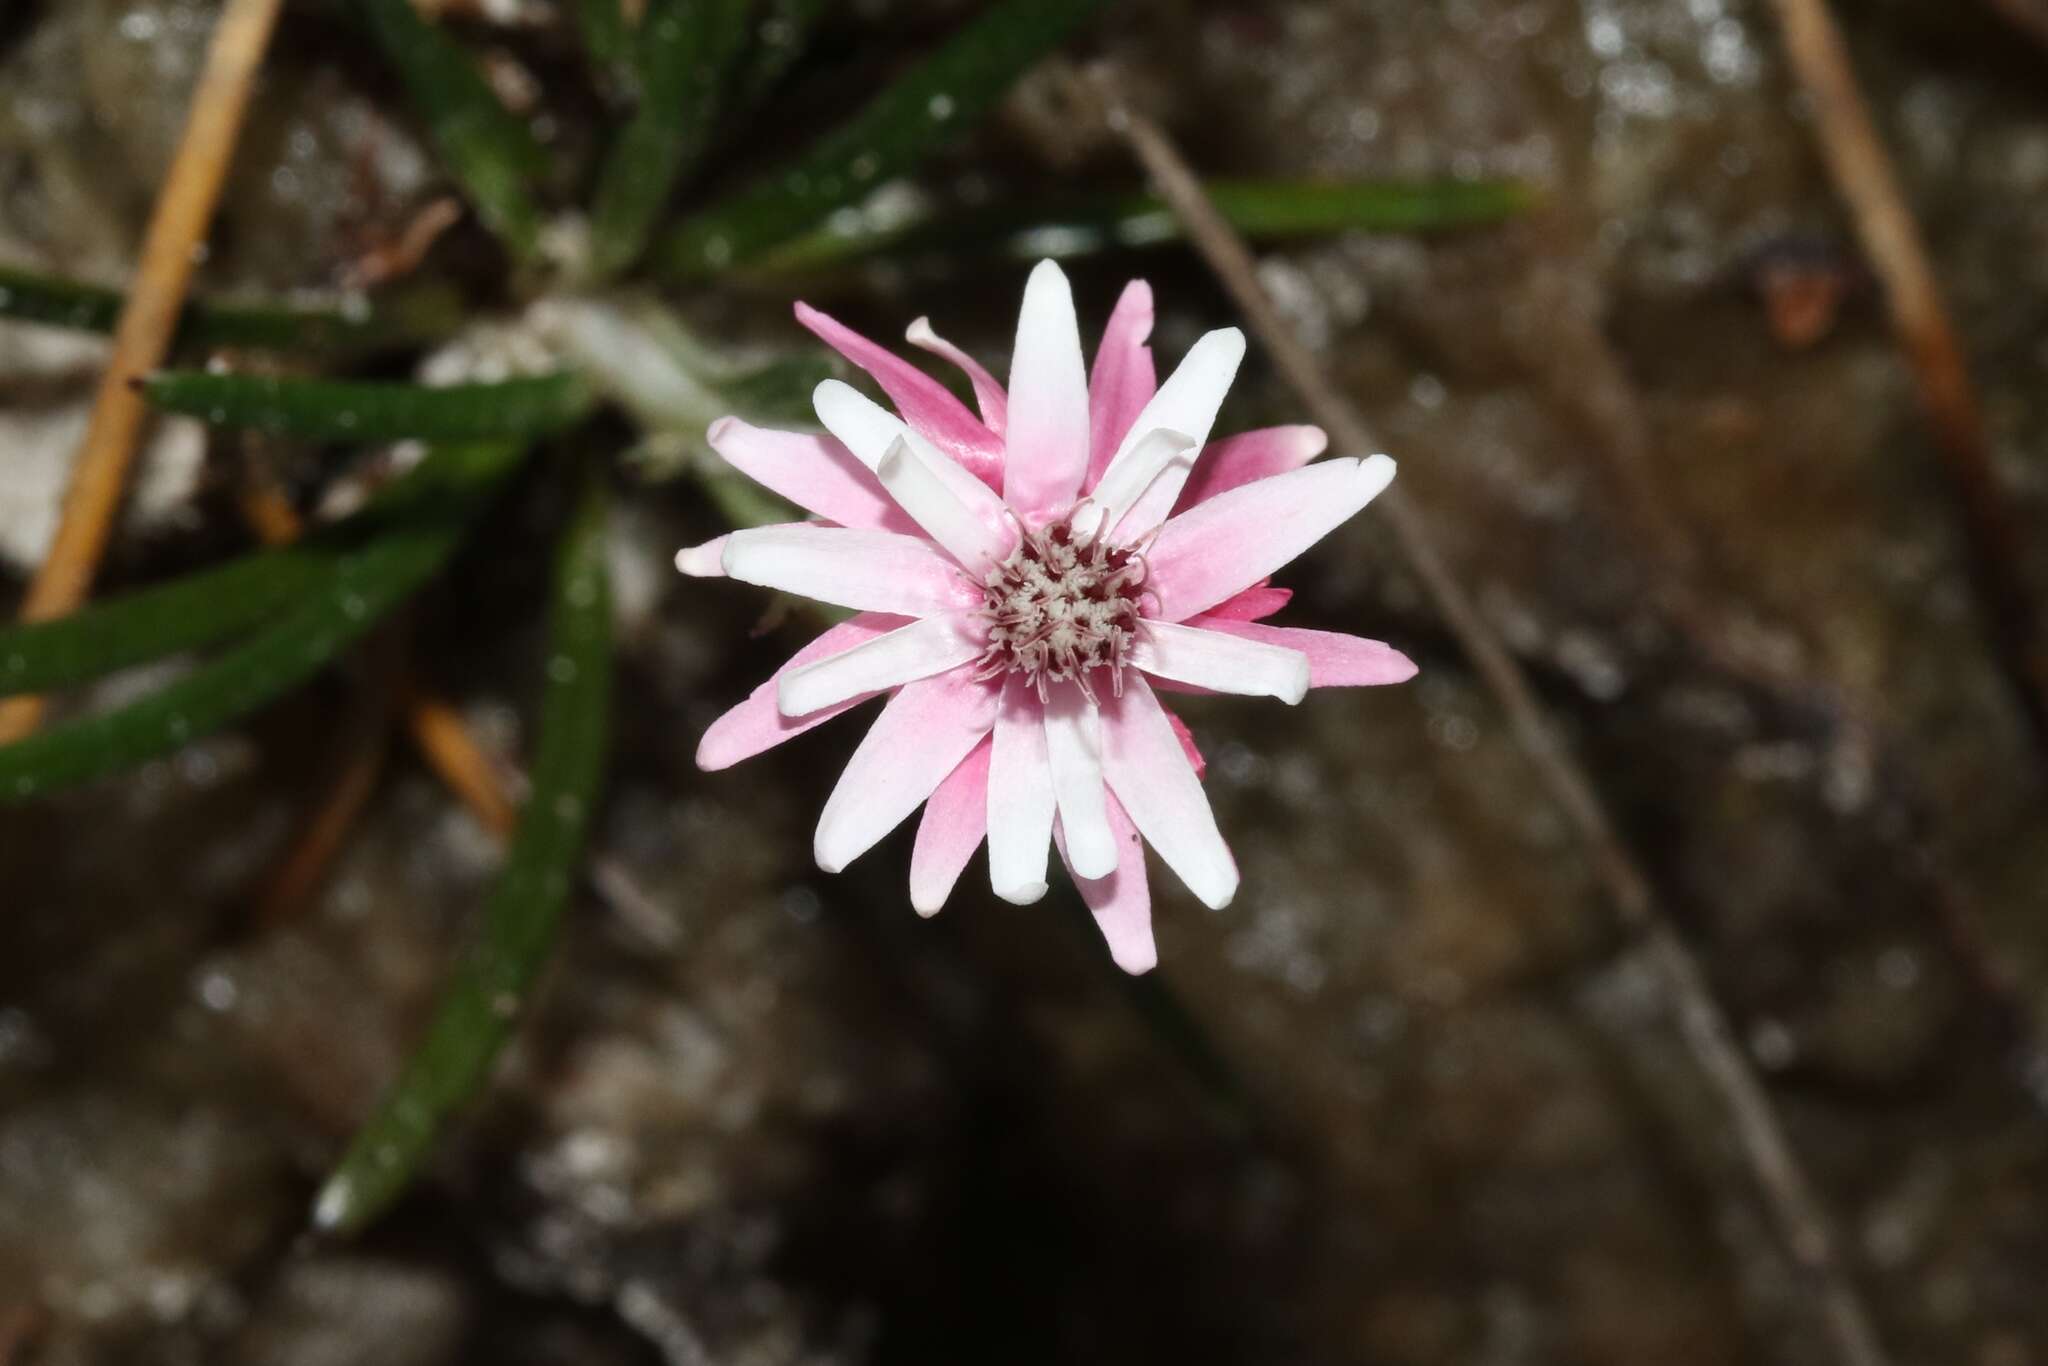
1004,260,1087,522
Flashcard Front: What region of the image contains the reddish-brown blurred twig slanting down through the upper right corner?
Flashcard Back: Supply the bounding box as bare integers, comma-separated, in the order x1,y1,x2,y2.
1772,0,2048,760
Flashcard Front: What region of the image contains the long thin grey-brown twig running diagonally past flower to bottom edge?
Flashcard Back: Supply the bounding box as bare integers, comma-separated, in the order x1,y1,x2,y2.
1098,70,1886,1366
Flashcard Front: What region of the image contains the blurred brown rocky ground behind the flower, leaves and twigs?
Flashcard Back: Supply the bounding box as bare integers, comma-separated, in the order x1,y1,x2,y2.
0,0,2048,1366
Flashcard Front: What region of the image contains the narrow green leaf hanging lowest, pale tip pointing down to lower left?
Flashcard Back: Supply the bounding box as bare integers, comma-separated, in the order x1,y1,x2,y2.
313,464,612,1233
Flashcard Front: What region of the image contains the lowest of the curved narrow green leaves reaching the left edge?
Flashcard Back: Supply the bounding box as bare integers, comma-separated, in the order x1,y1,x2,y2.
0,446,520,803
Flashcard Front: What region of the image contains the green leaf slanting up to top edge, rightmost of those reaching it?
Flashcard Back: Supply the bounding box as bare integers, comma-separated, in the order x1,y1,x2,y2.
662,0,1102,279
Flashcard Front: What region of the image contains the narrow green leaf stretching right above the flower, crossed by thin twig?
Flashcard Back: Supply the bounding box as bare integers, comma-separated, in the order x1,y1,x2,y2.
748,180,1536,272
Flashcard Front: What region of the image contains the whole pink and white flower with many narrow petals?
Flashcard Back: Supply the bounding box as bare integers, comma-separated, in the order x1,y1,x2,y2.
676,262,1415,973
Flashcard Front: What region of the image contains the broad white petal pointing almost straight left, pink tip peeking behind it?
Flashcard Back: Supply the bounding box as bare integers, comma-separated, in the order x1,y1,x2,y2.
723,524,981,616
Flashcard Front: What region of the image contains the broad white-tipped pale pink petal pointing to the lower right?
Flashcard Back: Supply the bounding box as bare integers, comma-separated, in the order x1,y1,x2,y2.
1102,674,1237,911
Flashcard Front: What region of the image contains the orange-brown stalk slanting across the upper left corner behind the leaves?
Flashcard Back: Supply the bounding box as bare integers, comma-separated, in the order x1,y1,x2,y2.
0,0,281,743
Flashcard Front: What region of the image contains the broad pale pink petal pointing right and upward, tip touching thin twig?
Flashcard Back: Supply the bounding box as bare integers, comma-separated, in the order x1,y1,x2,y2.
1145,455,1395,621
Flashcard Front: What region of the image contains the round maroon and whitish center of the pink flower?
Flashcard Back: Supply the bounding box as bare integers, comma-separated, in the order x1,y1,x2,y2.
979,516,1145,700
